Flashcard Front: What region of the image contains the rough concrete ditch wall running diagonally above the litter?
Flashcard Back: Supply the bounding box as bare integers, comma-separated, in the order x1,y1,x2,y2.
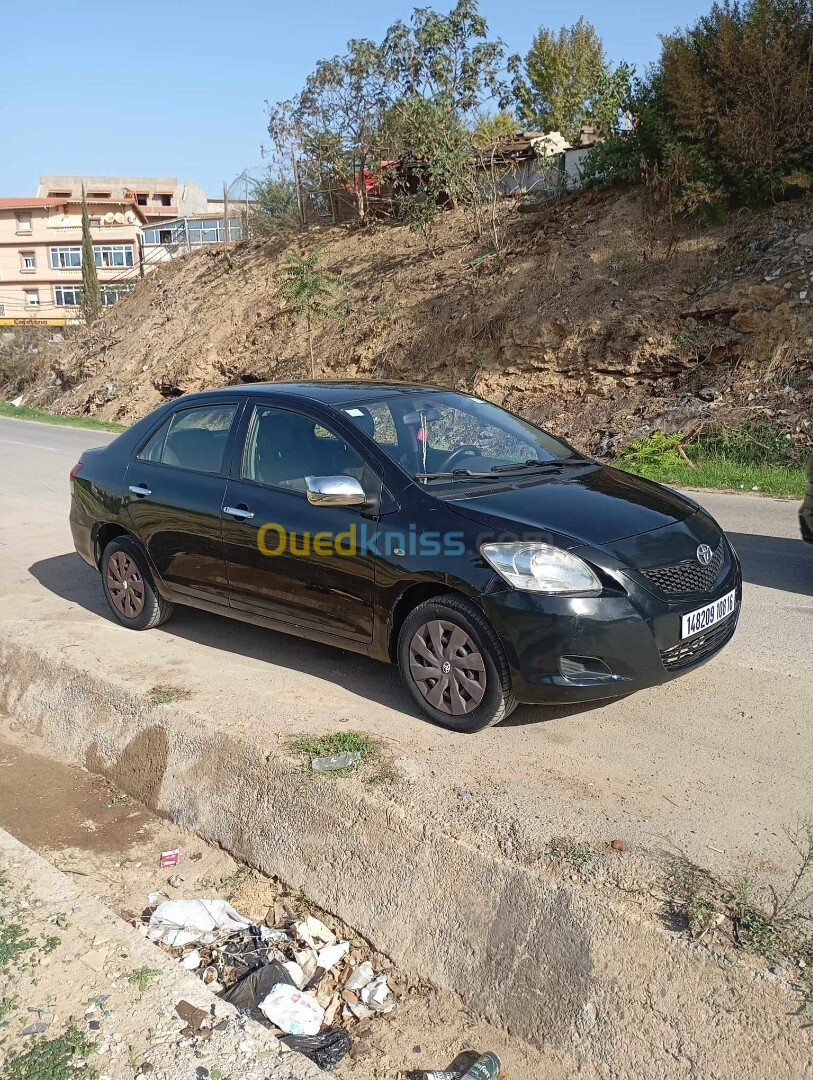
0,636,813,1080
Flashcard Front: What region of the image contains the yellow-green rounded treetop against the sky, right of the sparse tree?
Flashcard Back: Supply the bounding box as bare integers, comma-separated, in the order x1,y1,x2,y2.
510,18,632,143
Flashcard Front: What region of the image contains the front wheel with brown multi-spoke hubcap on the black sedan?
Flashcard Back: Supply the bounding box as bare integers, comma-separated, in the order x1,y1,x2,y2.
397,593,516,734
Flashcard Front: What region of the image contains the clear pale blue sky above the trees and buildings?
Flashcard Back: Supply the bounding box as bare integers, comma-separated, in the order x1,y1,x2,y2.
0,0,710,197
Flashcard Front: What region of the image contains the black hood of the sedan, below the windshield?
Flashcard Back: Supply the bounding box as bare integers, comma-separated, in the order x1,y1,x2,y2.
440,465,696,546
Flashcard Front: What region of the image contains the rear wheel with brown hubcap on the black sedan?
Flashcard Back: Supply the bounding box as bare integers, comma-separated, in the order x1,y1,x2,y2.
99,536,175,630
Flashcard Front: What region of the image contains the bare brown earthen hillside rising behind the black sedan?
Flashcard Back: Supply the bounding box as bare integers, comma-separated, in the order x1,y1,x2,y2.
26,193,813,451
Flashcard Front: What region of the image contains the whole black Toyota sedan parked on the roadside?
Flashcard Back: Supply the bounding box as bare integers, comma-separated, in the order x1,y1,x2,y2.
70,382,742,732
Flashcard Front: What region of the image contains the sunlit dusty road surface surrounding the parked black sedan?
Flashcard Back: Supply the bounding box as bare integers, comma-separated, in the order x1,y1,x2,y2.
0,418,813,877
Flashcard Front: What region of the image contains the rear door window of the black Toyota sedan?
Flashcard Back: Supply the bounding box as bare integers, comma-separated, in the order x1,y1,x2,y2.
138,405,236,473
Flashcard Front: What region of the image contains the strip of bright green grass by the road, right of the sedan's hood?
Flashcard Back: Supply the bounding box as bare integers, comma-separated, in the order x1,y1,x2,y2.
616,458,805,499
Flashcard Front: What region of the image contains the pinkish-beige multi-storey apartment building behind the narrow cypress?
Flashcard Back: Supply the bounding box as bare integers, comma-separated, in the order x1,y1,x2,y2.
0,192,147,326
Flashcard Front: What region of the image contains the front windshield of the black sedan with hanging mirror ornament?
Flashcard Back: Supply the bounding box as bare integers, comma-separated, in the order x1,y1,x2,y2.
341,391,585,483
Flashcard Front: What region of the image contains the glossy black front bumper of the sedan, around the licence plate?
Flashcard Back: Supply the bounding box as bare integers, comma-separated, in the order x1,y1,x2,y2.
480,551,742,703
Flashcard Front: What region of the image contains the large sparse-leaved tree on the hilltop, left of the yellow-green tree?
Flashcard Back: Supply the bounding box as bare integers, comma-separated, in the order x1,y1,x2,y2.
269,0,507,221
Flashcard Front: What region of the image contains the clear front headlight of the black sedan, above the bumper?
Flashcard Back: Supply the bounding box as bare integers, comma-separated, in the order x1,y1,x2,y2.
480,541,601,596
